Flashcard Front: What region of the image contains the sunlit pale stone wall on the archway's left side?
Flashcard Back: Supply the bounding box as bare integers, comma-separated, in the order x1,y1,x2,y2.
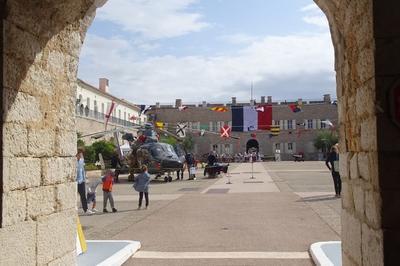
0,0,94,265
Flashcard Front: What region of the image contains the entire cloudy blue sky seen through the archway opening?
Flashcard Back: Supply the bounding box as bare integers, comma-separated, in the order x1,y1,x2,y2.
78,0,336,104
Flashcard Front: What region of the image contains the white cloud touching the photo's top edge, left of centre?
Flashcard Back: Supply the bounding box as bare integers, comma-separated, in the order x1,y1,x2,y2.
97,0,209,39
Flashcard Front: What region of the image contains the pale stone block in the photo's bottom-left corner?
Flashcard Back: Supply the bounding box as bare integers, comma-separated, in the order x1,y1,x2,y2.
0,222,36,266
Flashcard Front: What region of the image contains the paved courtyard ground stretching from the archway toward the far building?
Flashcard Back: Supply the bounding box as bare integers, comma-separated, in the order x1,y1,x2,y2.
80,162,341,265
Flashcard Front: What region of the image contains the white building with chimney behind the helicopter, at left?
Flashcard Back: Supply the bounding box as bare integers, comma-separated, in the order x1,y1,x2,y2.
75,78,146,141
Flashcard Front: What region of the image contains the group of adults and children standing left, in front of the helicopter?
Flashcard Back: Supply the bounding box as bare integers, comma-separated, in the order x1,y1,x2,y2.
76,150,150,215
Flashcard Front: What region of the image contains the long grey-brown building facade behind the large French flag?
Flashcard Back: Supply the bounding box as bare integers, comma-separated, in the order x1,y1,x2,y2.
148,95,338,160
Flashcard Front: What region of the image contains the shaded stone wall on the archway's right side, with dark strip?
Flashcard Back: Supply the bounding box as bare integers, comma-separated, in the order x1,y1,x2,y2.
316,0,400,265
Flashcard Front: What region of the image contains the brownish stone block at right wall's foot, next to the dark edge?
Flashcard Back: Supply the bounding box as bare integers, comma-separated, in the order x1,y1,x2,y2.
362,224,384,266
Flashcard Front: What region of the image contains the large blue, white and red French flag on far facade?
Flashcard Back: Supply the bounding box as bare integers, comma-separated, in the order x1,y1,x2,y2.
232,104,272,132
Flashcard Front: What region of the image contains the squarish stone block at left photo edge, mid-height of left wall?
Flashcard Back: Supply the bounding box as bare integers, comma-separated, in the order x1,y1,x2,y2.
3,123,28,157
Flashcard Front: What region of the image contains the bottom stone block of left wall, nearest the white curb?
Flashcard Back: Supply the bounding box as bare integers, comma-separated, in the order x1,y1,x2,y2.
37,211,77,265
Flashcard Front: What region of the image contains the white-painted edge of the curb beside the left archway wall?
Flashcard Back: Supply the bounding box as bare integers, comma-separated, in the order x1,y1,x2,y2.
86,240,141,266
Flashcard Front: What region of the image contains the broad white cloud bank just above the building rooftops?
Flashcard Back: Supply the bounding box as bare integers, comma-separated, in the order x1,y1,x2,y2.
79,33,335,103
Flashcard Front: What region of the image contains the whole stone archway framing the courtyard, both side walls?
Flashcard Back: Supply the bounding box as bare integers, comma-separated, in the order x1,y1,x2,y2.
0,0,400,265
